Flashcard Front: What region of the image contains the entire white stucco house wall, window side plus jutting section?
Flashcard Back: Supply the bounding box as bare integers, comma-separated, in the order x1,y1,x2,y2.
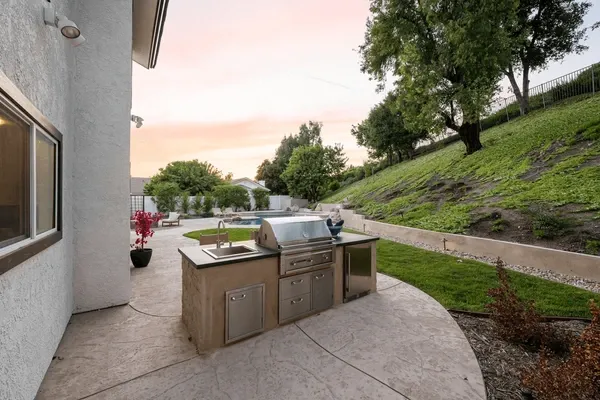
0,0,132,400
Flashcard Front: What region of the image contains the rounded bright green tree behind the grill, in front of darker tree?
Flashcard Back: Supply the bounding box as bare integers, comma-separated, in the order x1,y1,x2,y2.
282,144,344,203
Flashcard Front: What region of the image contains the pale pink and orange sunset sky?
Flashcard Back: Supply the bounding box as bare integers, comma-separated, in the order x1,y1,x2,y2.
131,0,600,178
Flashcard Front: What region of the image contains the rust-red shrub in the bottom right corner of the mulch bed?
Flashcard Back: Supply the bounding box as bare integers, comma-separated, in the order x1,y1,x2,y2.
522,300,600,400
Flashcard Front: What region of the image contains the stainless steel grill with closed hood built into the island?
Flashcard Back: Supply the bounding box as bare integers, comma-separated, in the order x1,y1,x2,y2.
256,217,335,275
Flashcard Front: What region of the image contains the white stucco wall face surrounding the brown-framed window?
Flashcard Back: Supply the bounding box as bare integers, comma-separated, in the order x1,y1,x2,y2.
0,0,77,400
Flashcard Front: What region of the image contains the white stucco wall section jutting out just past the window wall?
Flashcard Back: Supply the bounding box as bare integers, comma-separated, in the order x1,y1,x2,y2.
72,0,132,312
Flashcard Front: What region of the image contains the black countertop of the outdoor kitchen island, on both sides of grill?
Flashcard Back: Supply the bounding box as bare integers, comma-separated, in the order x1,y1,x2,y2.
179,232,379,269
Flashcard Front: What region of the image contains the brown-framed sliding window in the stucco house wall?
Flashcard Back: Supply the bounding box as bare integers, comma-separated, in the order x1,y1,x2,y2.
0,82,61,274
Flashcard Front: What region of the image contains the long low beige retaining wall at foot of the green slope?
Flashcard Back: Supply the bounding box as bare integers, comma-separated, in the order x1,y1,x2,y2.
322,204,600,281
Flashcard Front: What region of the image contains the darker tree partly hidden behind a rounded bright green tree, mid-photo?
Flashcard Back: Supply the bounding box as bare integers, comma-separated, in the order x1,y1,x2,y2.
256,121,323,194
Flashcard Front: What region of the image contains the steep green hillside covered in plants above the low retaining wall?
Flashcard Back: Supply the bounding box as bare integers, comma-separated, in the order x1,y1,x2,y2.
322,95,600,233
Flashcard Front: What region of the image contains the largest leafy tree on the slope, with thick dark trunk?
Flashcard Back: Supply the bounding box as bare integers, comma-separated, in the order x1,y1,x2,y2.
359,0,516,154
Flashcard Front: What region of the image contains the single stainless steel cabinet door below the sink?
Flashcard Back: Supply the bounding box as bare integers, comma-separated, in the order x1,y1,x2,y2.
225,283,265,343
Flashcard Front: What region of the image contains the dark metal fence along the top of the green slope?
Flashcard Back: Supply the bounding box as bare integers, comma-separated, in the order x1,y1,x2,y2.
481,63,600,130
